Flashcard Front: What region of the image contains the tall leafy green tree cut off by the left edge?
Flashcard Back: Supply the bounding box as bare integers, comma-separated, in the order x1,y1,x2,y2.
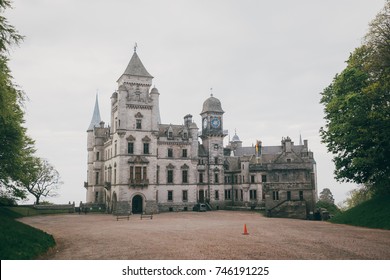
0,0,35,201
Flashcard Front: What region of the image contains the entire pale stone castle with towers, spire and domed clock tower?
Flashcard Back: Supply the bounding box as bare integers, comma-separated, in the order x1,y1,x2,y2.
84,50,317,219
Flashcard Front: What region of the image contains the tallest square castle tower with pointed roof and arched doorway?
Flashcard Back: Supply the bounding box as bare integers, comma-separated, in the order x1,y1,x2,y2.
106,49,161,213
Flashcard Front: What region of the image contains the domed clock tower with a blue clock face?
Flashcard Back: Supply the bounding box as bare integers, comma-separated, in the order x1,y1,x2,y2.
200,95,226,202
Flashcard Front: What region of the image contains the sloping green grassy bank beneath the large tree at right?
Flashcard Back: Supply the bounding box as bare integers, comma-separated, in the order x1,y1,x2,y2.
330,196,390,230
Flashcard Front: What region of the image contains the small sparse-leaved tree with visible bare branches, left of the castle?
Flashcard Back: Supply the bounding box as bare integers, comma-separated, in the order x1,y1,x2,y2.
18,158,62,204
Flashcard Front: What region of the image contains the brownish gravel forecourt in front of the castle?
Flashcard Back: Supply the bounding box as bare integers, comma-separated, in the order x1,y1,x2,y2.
20,211,390,260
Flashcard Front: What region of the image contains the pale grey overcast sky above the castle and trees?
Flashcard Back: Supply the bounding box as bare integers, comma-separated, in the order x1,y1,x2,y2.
6,0,385,204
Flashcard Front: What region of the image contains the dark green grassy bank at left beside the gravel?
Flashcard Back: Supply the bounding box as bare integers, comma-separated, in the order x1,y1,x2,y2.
0,207,55,260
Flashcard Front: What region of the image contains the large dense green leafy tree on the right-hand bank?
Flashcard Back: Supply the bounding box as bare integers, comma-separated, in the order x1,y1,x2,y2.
320,1,390,194
